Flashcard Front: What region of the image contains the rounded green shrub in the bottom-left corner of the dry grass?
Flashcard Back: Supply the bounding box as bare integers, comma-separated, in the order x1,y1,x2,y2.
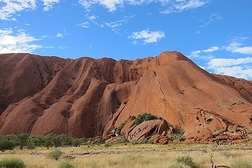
0,158,25,168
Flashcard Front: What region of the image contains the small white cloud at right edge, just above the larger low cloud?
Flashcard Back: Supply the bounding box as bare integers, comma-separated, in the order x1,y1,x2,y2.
224,42,252,54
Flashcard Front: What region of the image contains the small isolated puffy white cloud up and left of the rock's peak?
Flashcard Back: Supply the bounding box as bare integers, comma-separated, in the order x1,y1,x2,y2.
129,29,165,43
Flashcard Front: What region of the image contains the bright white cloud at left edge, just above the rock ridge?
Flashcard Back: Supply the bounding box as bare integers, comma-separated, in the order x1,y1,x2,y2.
0,28,42,53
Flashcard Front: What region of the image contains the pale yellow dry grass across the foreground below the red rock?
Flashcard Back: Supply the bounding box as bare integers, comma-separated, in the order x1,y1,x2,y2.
0,144,252,168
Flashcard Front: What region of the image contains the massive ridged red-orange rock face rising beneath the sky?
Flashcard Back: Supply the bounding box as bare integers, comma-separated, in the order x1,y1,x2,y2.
0,52,252,144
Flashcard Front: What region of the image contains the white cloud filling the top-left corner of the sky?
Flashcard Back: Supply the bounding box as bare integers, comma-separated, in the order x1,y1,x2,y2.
0,0,36,20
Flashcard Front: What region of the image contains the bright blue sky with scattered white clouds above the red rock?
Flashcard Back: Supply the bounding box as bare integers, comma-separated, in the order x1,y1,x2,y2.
0,0,252,80
